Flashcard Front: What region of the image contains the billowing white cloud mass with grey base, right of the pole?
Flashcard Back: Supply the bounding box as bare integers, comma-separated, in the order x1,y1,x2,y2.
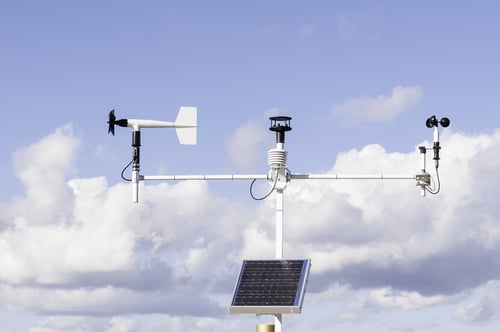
288,133,500,296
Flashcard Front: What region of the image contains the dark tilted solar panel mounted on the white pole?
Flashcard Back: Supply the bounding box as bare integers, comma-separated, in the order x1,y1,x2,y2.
229,259,311,314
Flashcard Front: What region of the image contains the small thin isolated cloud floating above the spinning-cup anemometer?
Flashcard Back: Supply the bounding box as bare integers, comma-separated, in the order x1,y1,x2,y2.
332,86,423,125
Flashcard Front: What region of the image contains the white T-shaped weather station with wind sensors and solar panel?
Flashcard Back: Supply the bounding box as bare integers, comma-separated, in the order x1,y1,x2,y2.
108,107,450,332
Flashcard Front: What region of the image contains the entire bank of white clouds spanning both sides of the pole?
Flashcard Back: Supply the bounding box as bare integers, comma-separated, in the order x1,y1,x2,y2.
4,127,500,331
